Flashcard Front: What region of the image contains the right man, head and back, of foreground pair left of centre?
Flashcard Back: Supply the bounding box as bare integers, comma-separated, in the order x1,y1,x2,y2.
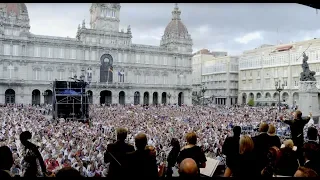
127,133,159,179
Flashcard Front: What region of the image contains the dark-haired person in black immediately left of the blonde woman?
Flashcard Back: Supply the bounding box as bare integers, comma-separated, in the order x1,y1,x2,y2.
222,126,241,176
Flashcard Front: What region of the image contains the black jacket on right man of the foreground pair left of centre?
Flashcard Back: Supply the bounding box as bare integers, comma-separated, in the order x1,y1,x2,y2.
127,150,159,179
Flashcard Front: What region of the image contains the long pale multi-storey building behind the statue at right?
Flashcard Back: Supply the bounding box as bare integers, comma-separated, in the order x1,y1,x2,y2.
239,39,320,105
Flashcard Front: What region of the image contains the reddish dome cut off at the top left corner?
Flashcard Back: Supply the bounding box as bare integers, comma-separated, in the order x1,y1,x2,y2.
0,3,28,17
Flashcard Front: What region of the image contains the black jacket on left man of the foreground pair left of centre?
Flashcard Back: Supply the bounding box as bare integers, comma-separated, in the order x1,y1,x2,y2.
104,141,134,178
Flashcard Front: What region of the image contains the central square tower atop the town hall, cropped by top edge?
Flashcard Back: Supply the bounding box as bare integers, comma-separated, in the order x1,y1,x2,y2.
90,3,121,32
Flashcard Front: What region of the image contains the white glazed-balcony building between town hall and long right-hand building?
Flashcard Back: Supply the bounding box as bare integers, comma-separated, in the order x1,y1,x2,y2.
192,49,239,105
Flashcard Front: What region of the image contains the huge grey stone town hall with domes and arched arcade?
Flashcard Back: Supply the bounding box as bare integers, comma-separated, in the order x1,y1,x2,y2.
0,3,192,104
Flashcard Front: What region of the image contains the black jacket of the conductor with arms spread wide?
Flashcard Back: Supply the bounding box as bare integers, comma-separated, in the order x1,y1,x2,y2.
284,117,310,148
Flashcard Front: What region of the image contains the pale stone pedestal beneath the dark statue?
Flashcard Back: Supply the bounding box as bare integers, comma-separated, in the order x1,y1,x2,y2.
298,81,320,117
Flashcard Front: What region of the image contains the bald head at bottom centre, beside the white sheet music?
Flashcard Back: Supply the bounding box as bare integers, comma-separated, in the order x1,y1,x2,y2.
179,158,198,178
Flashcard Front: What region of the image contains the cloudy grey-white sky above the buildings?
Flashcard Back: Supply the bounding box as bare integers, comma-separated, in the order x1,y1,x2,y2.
26,3,320,55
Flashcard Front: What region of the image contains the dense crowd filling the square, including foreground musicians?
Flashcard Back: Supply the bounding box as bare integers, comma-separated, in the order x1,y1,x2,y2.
0,105,319,177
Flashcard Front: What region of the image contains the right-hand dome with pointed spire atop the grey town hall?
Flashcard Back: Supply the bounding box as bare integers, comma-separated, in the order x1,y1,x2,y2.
164,4,188,37
